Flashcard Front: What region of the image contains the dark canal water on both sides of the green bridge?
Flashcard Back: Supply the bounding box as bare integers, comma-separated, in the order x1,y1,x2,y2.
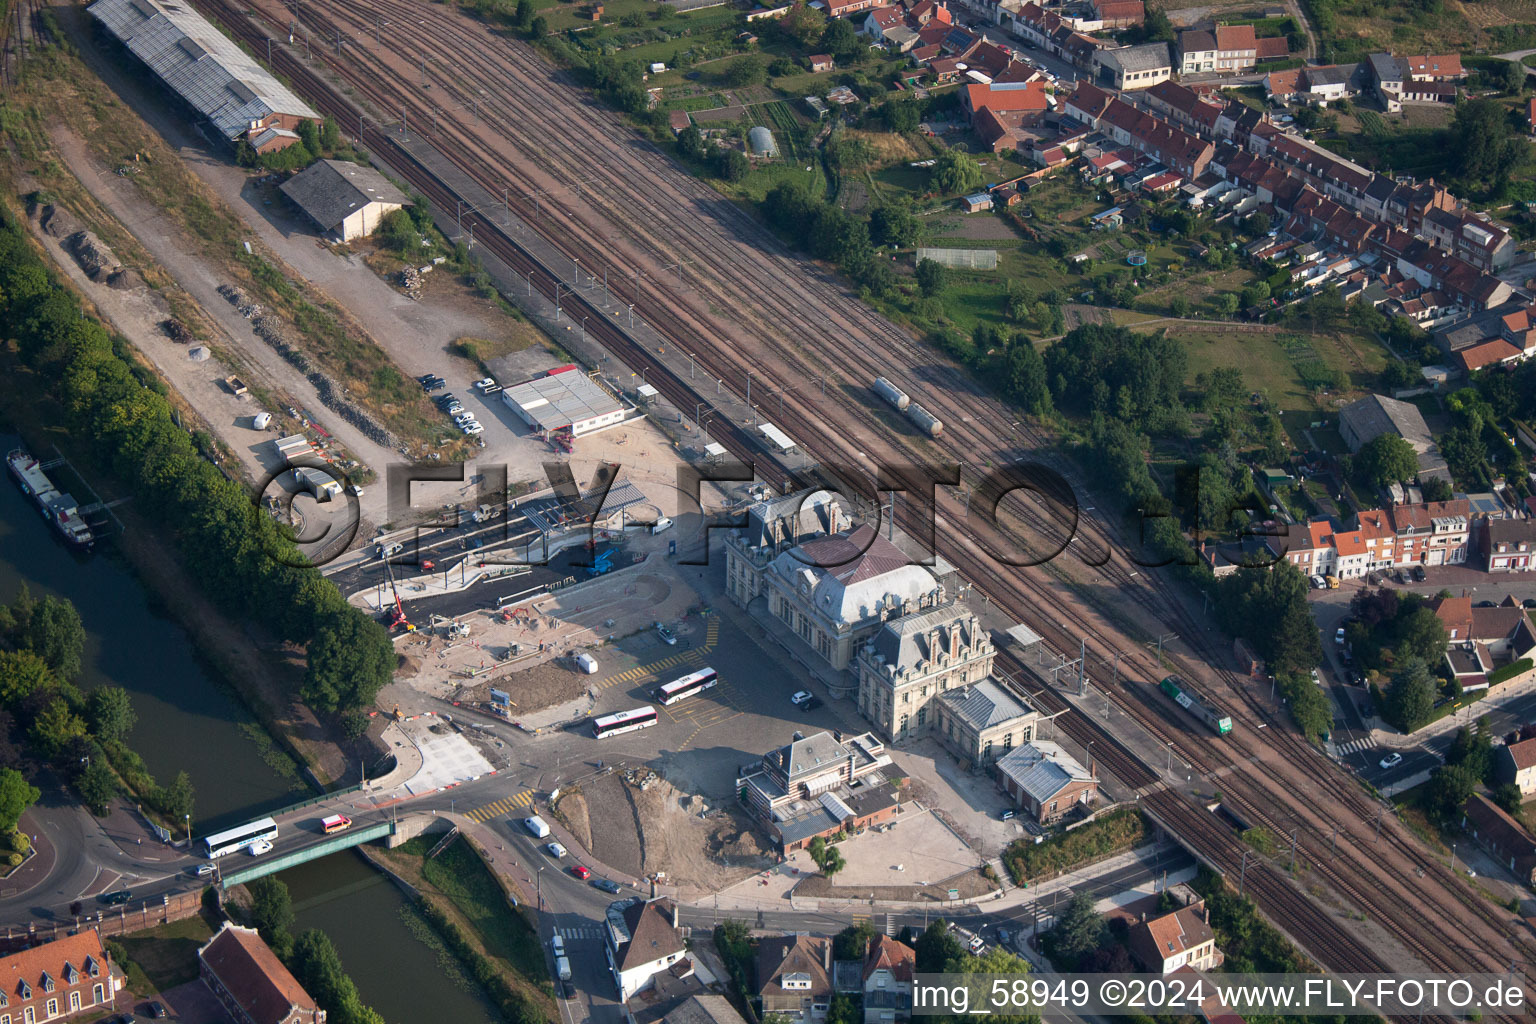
0,434,498,1024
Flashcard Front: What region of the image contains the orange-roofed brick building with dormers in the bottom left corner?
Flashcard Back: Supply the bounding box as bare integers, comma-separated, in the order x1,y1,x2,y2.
0,929,123,1024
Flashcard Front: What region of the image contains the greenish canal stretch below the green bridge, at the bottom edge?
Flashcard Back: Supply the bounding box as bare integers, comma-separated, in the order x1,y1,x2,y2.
280,852,501,1024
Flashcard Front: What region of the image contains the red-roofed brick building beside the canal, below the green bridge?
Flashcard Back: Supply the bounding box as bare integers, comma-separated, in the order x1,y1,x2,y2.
197,921,326,1024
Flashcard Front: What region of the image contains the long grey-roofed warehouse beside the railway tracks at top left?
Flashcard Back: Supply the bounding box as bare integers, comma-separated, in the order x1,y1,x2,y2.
88,0,321,154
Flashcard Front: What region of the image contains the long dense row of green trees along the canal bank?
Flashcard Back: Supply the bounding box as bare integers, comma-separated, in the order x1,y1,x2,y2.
0,212,395,724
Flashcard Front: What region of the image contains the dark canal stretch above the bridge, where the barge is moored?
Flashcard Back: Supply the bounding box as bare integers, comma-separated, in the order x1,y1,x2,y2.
0,434,297,834
